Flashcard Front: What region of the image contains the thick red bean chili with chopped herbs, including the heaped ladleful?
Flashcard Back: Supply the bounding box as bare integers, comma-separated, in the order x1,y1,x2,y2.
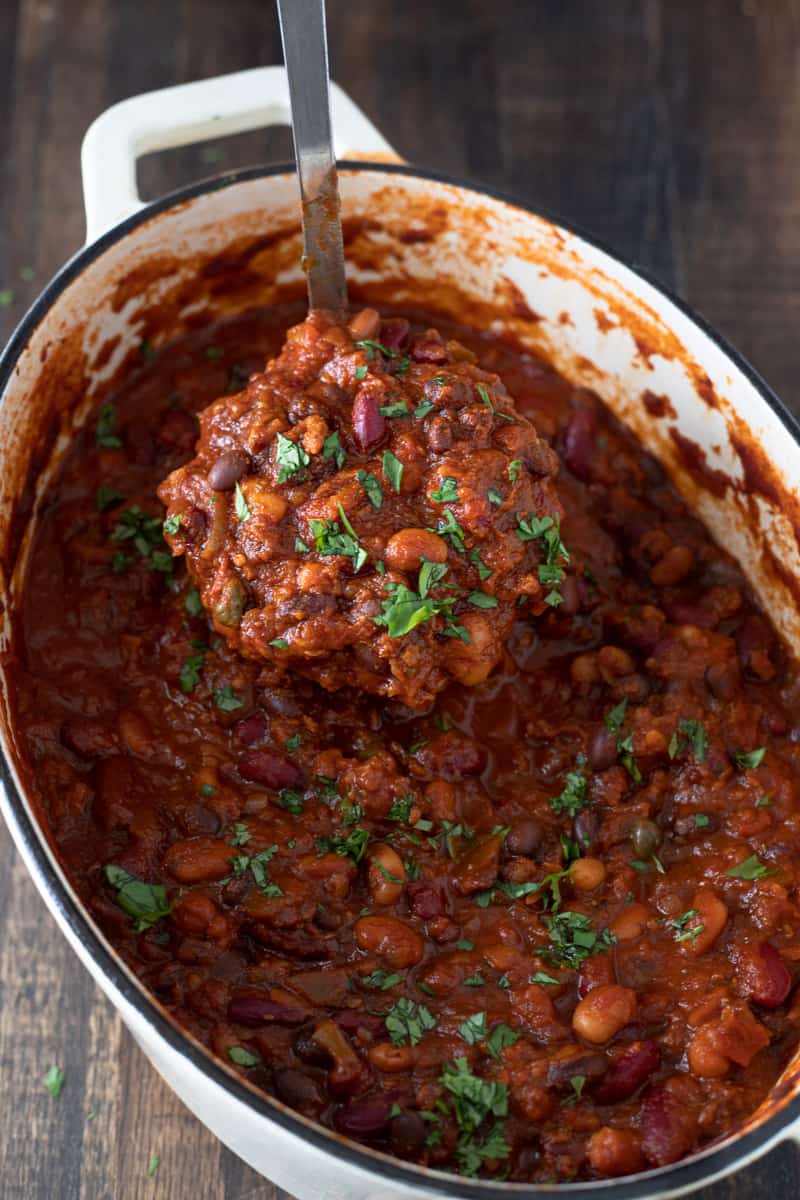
17,300,800,1181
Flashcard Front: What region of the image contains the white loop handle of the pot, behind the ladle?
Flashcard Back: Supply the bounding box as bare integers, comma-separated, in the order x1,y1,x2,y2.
80,67,401,244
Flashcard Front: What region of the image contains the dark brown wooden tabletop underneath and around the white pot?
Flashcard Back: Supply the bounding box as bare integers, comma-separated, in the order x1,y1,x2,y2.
0,0,800,1200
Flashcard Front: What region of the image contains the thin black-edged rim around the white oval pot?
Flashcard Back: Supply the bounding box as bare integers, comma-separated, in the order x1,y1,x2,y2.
0,160,800,1200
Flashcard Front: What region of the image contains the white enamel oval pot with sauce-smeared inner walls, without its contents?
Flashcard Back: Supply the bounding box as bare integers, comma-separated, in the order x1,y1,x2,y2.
0,67,800,1200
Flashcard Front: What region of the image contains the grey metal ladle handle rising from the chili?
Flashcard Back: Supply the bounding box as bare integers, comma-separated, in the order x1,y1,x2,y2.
278,0,348,317
